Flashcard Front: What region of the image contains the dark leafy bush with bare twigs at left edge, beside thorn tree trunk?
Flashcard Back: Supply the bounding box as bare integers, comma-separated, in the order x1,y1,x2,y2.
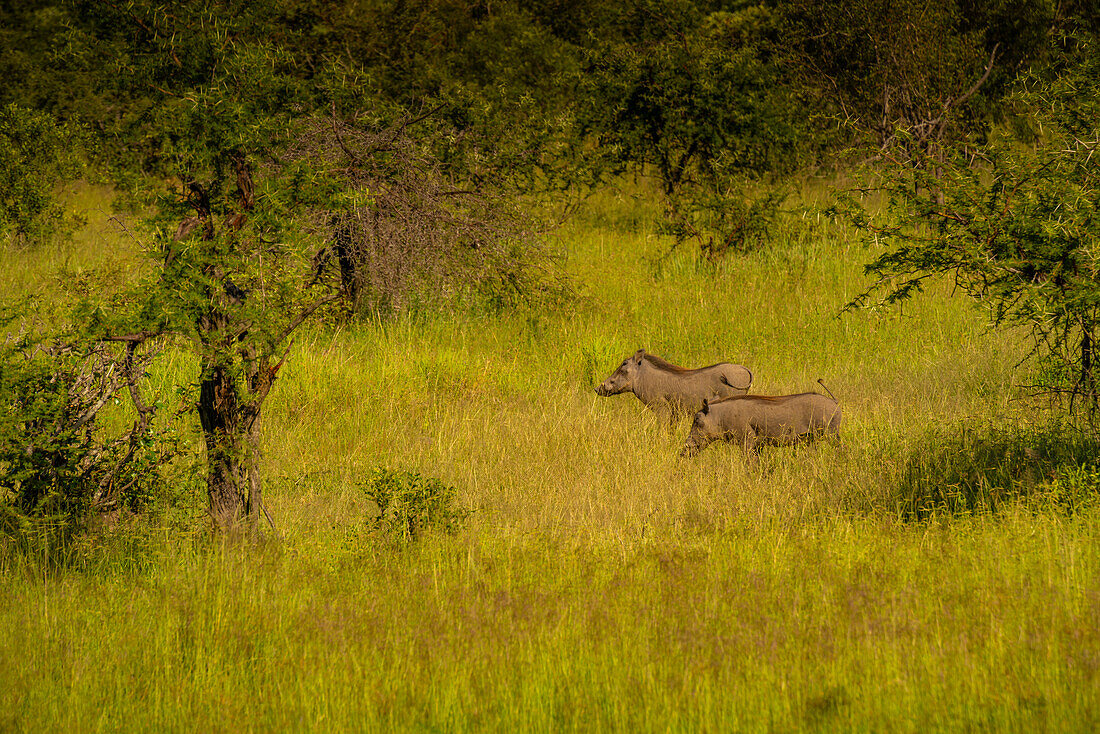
0,320,173,550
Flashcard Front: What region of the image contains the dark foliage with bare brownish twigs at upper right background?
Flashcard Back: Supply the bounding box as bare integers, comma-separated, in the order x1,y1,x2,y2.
779,0,1056,155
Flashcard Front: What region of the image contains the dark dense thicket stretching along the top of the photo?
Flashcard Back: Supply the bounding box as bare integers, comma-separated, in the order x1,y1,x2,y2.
0,0,1100,188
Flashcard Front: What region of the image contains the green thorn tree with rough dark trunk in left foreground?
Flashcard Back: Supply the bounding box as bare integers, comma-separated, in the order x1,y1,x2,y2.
49,2,337,529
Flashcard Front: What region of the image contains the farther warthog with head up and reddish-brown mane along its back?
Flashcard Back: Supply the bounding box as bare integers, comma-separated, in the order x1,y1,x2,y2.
596,349,752,424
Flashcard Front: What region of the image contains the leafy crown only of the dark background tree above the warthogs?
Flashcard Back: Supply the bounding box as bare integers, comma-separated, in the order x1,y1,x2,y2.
580,1,799,197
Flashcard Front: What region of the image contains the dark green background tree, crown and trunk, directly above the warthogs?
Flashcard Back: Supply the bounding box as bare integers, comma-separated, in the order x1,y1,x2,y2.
578,0,809,254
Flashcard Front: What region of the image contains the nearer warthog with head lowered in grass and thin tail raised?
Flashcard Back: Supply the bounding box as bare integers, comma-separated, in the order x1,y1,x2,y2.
680,380,840,457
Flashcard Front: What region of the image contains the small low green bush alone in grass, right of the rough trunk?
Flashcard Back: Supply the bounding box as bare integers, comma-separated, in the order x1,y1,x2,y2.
363,467,470,541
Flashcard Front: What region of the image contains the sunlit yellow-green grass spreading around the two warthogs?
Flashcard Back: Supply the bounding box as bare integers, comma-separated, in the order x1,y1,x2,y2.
0,182,1100,732
